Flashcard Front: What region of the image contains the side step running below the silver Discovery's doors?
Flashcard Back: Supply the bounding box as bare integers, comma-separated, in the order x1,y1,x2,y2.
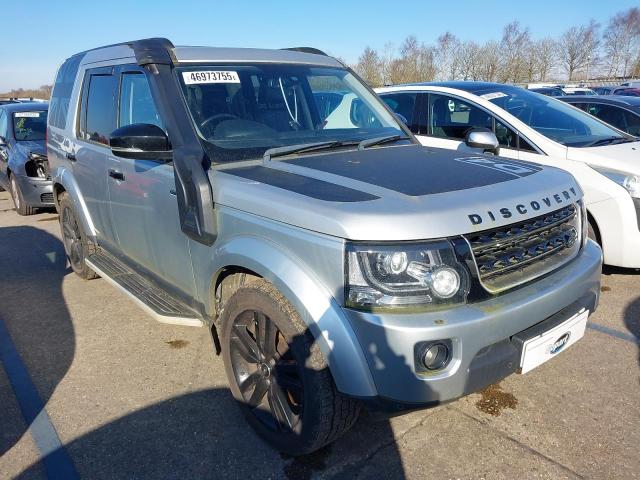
85,250,203,327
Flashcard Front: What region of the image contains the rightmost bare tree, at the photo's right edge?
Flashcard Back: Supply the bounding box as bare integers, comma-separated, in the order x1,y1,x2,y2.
602,7,640,77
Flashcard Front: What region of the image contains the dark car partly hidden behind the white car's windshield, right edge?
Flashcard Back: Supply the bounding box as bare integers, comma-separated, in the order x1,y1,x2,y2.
559,95,640,137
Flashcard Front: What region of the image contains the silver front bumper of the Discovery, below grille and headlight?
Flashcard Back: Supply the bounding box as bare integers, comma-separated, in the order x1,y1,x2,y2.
345,241,602,411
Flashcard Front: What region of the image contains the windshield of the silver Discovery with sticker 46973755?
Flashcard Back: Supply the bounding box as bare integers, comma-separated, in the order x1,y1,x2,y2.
178,64,408,163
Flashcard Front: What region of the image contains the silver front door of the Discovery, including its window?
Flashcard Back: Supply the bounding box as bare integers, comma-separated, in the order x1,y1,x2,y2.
108,65,195,296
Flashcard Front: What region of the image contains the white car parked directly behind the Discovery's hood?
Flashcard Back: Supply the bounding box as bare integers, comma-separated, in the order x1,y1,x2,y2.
377,82,640,268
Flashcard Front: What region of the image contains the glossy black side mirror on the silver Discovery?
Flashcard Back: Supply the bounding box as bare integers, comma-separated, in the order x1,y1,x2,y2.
109,123,173,161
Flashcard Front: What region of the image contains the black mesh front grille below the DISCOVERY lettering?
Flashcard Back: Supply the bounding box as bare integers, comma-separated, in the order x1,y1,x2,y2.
465,205,581,293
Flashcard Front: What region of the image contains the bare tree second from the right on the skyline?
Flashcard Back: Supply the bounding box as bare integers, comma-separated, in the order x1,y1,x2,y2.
559,20,600,80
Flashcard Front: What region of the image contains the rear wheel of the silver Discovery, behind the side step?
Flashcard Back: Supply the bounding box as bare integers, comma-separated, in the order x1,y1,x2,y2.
58,192,98,280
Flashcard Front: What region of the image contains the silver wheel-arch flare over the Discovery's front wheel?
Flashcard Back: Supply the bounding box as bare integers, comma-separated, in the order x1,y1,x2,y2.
212,236,376,397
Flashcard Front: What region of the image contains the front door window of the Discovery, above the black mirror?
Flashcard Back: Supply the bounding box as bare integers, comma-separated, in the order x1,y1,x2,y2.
118,73,162,128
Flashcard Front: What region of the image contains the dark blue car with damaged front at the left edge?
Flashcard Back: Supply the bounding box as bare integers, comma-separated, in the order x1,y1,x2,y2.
0,102,54,215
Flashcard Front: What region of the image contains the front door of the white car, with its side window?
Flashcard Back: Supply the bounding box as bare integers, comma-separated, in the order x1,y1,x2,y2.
418,93,520,158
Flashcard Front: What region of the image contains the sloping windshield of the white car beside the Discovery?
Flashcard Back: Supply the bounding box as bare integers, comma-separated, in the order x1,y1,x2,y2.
474,86,629,147
